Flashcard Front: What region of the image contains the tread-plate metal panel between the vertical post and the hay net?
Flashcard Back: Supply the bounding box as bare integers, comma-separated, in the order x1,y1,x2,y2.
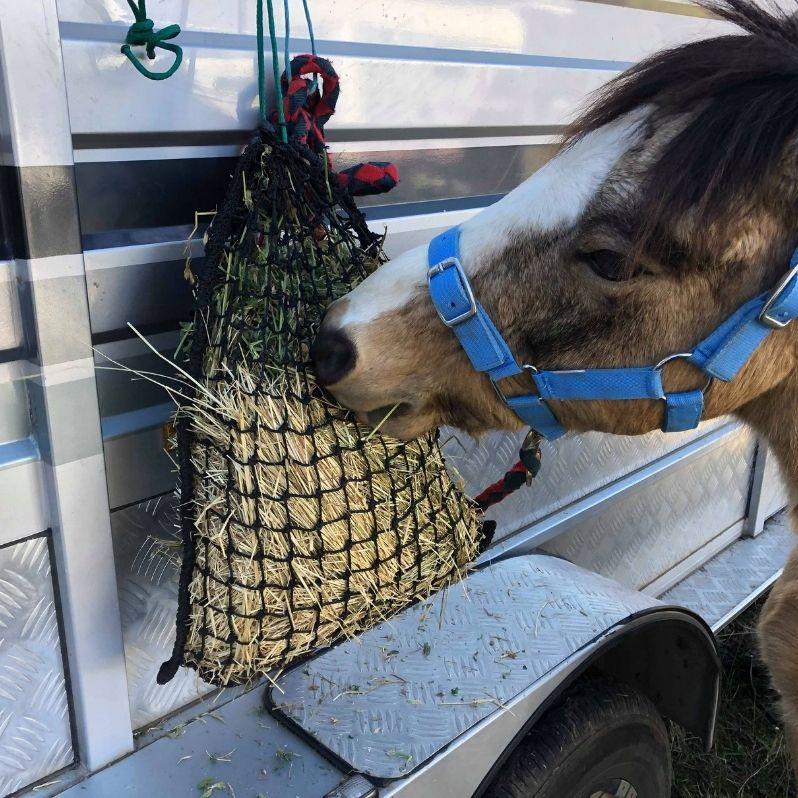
111,495,213,729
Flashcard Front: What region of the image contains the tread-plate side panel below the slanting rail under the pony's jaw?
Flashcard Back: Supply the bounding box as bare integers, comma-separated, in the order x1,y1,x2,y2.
542,427,756,589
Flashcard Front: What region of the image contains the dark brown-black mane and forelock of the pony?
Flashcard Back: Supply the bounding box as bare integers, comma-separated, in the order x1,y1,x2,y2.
566,0,798,256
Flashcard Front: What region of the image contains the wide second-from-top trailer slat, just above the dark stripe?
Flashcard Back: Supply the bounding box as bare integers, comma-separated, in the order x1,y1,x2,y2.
62,39,625,133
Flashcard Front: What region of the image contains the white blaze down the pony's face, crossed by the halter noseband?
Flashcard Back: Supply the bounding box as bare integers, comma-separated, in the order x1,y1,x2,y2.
339,111,645,328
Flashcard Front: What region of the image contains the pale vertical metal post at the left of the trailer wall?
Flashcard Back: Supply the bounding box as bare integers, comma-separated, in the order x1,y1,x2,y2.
0,0,132,780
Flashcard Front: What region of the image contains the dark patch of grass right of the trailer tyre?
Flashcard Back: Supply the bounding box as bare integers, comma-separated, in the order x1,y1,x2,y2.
671,600,798,798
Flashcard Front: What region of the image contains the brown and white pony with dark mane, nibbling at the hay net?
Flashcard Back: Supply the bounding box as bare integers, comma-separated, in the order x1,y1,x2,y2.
313,0,798,762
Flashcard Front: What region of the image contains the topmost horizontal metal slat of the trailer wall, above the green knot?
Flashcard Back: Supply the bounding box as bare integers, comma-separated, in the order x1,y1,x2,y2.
58,0,721,61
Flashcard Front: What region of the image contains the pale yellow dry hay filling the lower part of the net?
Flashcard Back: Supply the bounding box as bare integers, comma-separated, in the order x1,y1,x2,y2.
187,374,477,683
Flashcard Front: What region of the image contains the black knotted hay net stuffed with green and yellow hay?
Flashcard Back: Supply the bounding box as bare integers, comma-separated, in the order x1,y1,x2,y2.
158,126,480,684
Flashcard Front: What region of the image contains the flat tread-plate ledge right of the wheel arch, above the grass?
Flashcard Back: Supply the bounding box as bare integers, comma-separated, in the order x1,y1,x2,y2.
660,512,795,629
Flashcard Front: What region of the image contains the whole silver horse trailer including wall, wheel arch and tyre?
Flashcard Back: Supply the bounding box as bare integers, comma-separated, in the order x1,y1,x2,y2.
0,0,791,798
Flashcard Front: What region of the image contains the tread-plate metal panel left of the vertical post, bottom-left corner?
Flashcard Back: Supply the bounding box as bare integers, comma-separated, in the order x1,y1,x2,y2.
0,538,74,795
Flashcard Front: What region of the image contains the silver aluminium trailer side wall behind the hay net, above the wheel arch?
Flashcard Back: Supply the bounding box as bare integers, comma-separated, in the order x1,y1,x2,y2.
0,0,785,795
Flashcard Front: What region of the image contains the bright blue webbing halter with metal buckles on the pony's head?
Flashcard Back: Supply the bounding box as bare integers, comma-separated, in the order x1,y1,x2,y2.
427,227,798,440
